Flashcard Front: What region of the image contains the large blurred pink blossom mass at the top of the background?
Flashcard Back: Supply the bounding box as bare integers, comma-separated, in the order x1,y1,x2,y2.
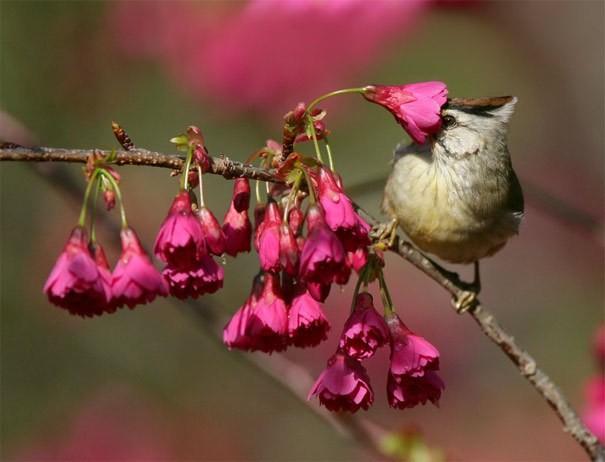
109,0,431,115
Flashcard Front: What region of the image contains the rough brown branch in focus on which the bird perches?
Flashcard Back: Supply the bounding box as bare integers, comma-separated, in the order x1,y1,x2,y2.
0,145,605,462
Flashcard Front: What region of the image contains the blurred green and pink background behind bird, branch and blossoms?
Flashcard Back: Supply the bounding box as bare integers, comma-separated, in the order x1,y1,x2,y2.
0,0,605,461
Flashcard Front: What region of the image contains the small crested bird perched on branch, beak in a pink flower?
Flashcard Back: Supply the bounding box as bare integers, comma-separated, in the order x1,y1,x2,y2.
382,96,524,312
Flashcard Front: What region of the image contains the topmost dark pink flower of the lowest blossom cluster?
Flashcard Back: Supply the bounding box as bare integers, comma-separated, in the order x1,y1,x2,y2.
338,292,389,360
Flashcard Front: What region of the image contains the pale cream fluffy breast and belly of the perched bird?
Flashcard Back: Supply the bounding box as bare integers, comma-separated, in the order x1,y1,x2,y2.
383,155,518,263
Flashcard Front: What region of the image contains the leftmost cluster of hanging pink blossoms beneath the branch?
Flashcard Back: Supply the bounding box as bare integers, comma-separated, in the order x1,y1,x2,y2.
44,226,168,317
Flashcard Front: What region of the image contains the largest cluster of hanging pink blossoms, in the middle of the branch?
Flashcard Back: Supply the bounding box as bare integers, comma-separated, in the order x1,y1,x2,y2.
223,166,370,353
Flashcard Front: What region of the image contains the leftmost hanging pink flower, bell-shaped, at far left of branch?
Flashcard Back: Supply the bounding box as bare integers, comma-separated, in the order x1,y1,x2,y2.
43,226,111,316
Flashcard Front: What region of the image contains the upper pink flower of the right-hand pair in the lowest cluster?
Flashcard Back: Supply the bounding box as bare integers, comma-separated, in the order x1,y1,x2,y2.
387,314,439,377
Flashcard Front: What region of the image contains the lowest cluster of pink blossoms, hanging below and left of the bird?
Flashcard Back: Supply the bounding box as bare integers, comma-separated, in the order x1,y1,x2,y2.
309,292,444,412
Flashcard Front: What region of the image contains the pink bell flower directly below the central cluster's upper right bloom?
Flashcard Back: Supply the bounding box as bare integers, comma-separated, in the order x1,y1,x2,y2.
300,206,345,284
